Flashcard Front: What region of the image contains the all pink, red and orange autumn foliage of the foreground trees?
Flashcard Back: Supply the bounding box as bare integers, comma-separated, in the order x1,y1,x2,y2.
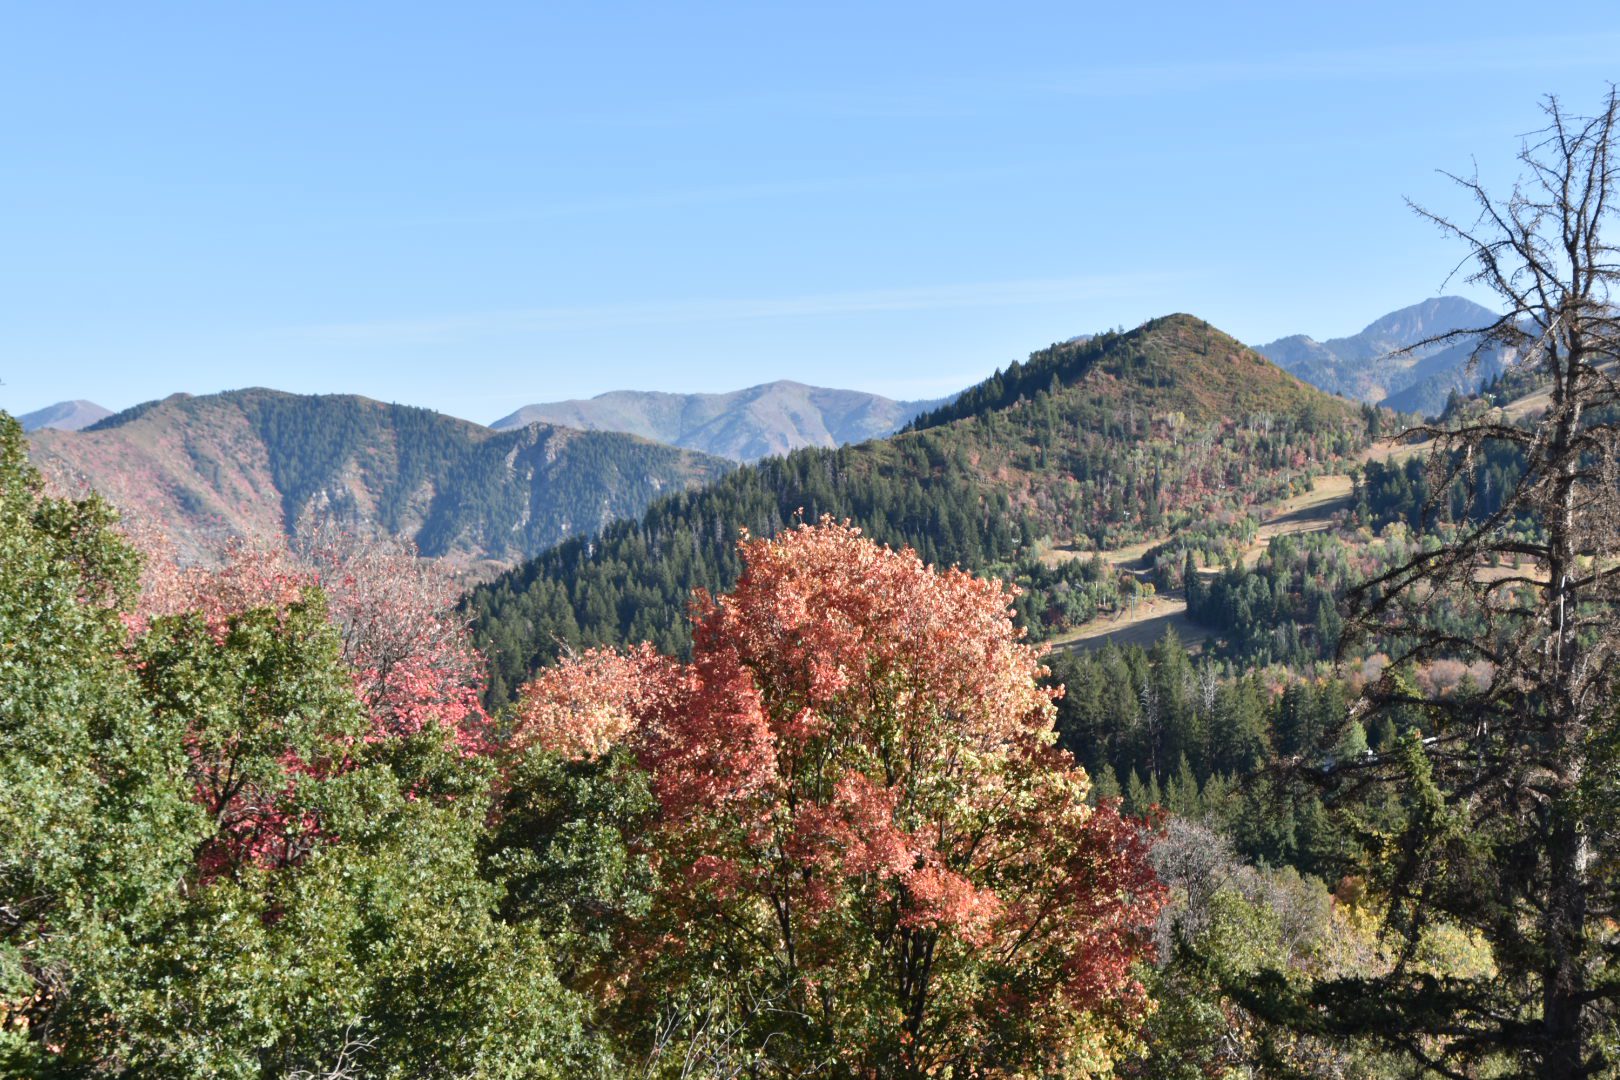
130,520,1165,1074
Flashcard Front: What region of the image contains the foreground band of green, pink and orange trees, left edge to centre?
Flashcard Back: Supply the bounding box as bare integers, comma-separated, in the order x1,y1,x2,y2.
0,418,1165,1077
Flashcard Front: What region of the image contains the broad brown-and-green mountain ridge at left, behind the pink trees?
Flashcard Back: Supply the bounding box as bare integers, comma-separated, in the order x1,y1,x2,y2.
29,390,731,563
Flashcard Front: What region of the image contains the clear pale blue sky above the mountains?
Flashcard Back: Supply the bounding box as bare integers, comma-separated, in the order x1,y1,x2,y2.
0,0,1620,421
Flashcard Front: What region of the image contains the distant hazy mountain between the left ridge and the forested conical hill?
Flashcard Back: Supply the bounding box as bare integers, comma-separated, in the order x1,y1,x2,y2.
491,379,940,461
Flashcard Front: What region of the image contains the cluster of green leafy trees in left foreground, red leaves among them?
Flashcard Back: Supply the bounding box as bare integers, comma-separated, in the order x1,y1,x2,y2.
0,416,611,1077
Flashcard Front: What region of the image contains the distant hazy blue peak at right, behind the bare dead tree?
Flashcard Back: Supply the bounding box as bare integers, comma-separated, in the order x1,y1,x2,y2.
1259,296,1503,416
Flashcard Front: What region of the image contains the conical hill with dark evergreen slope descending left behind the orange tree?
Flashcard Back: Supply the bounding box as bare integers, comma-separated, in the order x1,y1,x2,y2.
468,314,1367,699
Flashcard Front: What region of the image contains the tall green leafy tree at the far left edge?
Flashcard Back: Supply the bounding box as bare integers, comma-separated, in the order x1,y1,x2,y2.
0,413,206,1075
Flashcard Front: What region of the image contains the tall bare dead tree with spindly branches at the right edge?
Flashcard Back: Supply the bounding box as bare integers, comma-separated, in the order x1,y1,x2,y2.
1257,87,1620,1080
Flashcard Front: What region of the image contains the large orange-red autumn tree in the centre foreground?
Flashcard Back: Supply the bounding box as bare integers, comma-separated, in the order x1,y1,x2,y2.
515,520,1163,1075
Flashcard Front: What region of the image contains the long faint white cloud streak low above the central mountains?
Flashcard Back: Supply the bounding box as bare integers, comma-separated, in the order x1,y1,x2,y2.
293,272,1184,345
